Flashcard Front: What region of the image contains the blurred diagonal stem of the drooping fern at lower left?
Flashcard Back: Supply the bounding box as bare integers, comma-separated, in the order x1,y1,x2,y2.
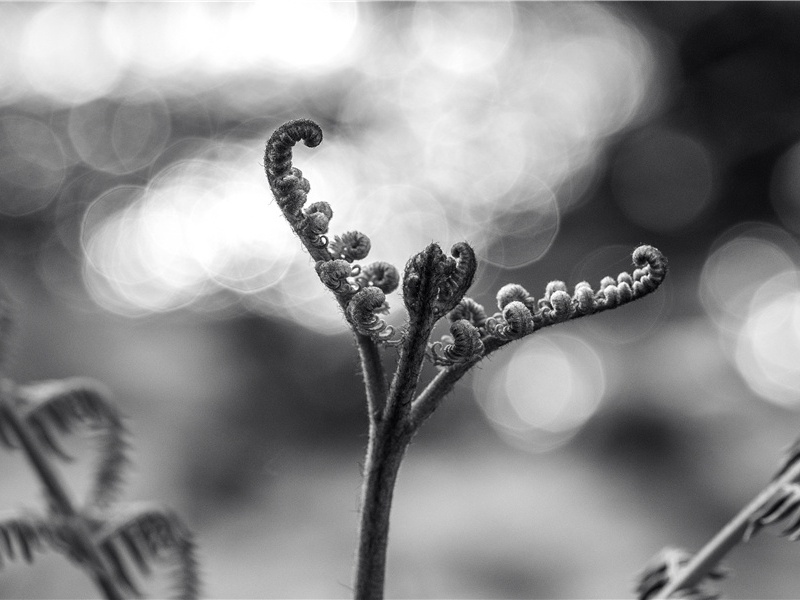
0,386,124,600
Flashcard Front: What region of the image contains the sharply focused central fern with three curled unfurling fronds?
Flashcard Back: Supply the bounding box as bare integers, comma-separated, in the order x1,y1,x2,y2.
264,119,667,599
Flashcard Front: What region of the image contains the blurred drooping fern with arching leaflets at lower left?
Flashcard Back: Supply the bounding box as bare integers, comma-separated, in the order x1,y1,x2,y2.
0,316,200,600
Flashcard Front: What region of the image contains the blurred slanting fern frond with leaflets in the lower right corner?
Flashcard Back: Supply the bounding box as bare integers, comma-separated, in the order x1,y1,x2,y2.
636,440,800,600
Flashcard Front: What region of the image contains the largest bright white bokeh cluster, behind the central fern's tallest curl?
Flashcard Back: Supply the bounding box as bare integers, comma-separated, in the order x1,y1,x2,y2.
0,1,656,332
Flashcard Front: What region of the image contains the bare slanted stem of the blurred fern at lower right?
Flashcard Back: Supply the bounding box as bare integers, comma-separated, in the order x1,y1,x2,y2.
653,452,800,600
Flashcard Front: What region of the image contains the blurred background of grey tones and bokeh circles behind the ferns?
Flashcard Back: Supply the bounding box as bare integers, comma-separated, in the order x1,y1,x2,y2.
0,2,800,598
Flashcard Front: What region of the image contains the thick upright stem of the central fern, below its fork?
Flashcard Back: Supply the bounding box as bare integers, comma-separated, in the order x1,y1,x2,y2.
353,410,411,600
